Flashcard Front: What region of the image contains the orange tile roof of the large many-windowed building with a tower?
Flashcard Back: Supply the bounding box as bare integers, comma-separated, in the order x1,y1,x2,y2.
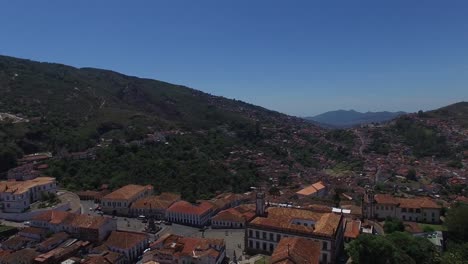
249,207,342,237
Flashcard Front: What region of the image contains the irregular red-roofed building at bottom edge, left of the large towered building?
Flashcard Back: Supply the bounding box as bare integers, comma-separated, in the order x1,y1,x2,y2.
143,234,226,264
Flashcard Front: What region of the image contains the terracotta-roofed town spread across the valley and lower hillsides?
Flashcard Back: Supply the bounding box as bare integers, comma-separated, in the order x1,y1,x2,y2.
0,116,468,264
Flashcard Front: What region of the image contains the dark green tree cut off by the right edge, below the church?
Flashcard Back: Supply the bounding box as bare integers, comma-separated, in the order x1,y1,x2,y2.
445,205,468,242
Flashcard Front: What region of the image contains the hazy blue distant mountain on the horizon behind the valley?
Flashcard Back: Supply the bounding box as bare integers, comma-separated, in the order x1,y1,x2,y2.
305,110,405,127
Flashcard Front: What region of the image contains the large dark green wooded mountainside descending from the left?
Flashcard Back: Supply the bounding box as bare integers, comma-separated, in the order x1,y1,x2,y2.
0,56,359,199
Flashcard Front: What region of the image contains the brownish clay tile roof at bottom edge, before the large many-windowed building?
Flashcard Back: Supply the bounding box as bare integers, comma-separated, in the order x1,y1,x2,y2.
271,237,320,264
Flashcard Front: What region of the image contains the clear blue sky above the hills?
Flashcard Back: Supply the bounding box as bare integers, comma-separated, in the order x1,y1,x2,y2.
0,0,468,116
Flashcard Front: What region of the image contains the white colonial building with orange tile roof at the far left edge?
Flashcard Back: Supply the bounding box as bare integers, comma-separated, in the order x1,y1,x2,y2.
0,177,57,213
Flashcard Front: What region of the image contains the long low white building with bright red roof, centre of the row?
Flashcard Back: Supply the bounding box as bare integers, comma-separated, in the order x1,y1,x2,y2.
166,201,214,226
